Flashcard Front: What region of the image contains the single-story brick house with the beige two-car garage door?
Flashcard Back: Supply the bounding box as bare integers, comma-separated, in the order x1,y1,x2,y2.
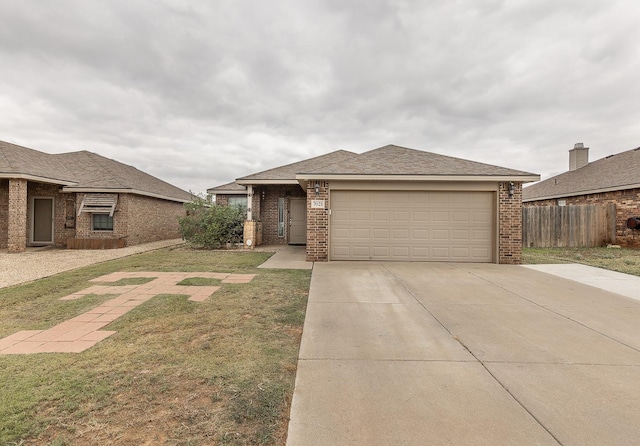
207,145,540,264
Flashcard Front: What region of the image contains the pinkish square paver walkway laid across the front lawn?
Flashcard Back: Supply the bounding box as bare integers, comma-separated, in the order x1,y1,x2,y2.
0,272,255,355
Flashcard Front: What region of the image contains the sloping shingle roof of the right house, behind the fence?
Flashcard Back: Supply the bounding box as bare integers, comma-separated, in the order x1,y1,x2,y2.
522,147,640,201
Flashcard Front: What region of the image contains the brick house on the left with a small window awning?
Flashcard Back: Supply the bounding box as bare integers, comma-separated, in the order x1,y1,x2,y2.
0,141,191,252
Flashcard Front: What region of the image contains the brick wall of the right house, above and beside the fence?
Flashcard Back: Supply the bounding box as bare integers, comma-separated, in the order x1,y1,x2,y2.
525,188,640,248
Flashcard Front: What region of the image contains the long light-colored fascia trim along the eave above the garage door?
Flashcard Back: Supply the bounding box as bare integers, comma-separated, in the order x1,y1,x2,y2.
296,174,540,183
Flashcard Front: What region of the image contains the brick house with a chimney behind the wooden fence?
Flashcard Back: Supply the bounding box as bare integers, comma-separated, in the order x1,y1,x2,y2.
522,143,640,248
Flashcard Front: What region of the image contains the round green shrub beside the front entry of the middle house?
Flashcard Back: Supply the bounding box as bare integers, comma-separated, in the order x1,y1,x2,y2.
179,197,245,249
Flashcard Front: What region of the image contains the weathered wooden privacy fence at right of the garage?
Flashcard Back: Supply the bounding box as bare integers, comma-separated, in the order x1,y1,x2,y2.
522,203,616,248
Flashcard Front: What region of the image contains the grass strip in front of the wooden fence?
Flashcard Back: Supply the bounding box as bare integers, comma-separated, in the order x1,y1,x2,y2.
522,248,640,276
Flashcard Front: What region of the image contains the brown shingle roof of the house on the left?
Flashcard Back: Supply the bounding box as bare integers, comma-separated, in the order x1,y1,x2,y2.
0,141,191,201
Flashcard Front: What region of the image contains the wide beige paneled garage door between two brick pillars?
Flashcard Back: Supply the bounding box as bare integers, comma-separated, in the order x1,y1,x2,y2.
330,191,495,262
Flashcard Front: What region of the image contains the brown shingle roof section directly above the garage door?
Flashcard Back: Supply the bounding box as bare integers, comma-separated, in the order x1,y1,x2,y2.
298,145,535,176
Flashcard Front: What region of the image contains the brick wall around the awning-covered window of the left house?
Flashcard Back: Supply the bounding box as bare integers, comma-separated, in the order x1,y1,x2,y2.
76,193,186,246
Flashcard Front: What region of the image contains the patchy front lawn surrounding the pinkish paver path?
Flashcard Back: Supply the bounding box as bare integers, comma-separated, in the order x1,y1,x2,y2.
0,249,311,445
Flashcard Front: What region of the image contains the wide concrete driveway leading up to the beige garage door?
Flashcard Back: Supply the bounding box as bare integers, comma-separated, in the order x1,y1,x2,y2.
287,262,640,446
